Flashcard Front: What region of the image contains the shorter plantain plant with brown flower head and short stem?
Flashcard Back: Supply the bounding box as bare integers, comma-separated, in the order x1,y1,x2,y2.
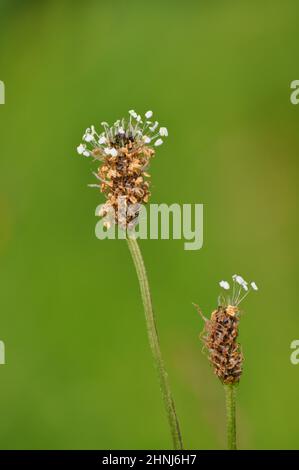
196,274,258,449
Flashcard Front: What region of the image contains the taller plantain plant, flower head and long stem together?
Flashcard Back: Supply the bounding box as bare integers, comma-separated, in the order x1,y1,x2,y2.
77,110,183,449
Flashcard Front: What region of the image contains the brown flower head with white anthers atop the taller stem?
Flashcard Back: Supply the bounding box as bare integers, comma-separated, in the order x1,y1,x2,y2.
77,109,168,229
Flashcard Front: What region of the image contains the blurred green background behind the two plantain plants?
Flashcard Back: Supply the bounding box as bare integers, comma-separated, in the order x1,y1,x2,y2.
0,0,299,449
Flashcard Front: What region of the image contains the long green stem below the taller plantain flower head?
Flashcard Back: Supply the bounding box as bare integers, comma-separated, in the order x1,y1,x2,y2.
127,237,183,450
